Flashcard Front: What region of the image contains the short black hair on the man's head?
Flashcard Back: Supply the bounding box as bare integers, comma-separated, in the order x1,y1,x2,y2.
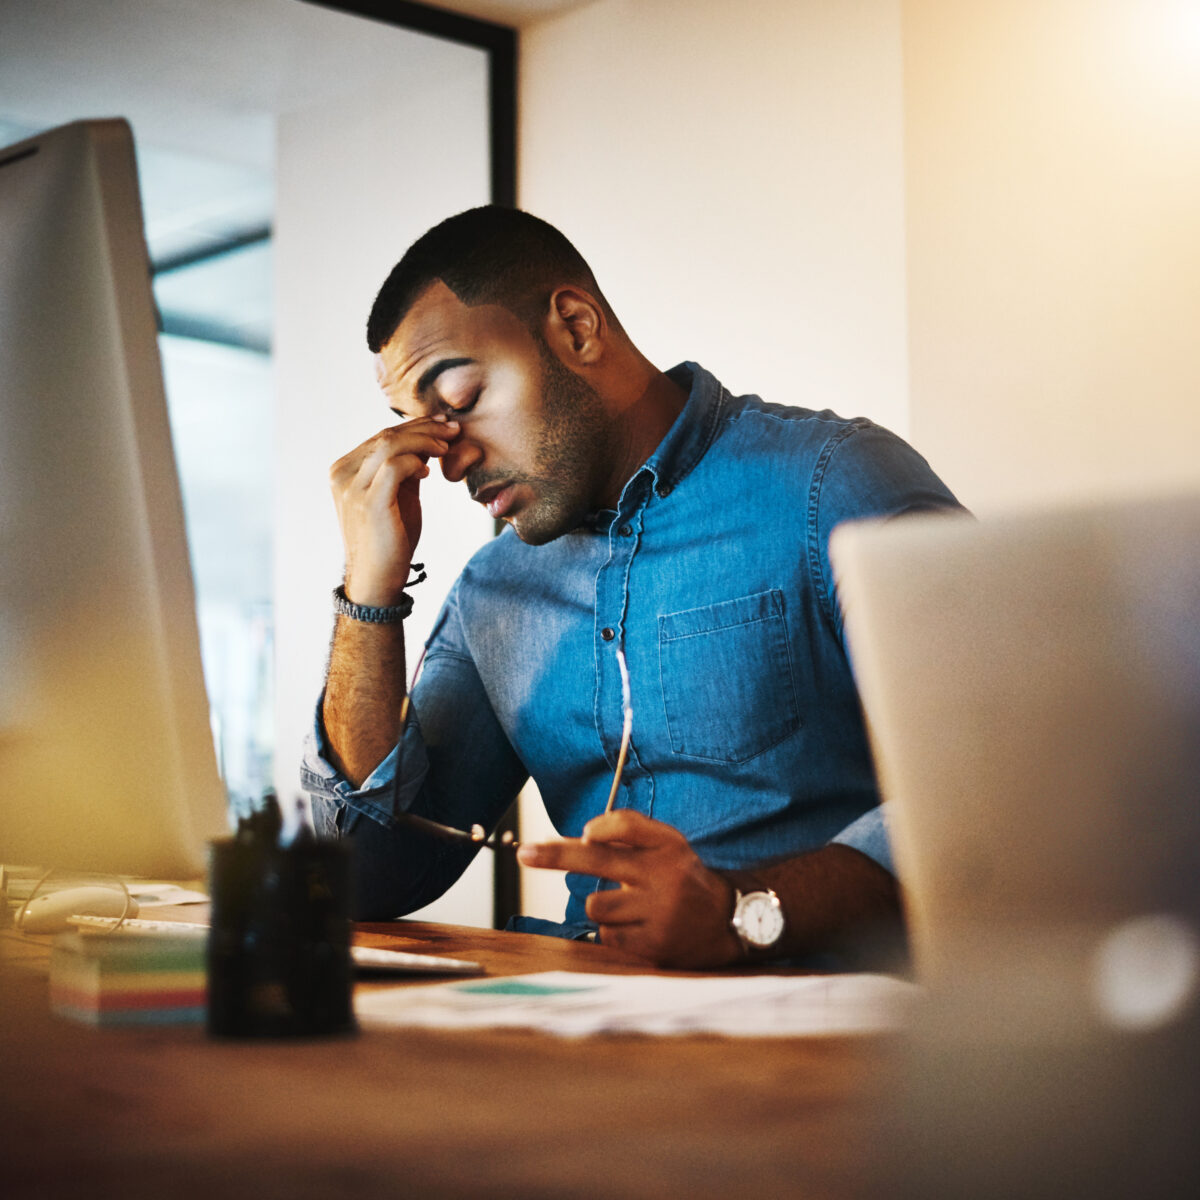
367,204,611,354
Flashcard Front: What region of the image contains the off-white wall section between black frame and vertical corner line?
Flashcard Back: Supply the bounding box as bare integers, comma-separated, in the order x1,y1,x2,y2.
520,0,907,433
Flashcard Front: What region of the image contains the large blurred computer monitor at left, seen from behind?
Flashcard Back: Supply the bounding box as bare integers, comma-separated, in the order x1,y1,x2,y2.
0,120,227,878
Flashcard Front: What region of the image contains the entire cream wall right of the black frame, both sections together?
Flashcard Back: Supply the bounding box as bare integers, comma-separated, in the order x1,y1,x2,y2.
520,0,1200,509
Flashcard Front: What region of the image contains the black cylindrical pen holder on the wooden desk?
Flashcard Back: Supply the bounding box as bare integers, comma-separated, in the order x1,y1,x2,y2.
208,839,356,1038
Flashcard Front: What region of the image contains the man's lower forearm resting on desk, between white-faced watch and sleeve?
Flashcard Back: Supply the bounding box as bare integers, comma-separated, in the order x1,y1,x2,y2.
718,844,904,958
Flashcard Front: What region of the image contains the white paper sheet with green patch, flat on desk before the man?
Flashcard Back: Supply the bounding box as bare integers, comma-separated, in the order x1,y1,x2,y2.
354,971,920,1037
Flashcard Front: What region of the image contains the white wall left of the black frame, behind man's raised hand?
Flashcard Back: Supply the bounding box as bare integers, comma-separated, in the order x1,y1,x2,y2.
275,35,491,925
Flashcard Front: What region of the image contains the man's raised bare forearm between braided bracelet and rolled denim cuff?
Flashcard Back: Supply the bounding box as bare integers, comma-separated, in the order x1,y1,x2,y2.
322,617,406,787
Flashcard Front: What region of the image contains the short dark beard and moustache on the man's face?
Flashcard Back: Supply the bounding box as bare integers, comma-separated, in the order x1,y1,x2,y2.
467,337,614,546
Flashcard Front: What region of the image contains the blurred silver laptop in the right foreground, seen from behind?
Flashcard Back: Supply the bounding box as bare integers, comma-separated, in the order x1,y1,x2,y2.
830,496,1200,1196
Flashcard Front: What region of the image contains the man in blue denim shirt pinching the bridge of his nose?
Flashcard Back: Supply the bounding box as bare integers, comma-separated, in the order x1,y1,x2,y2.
304,208,955,967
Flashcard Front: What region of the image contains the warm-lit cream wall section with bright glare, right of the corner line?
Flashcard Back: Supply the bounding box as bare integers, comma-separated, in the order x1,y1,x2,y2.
904,0,1200,510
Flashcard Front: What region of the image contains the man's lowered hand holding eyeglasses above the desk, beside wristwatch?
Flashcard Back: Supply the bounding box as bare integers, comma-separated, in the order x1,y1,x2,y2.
517,809,740,968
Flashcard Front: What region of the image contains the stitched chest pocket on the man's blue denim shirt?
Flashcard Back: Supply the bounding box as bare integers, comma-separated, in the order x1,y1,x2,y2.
659,588,800,762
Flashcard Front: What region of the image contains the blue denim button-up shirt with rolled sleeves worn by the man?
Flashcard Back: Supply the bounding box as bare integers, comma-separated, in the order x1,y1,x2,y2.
302,364,956,926
